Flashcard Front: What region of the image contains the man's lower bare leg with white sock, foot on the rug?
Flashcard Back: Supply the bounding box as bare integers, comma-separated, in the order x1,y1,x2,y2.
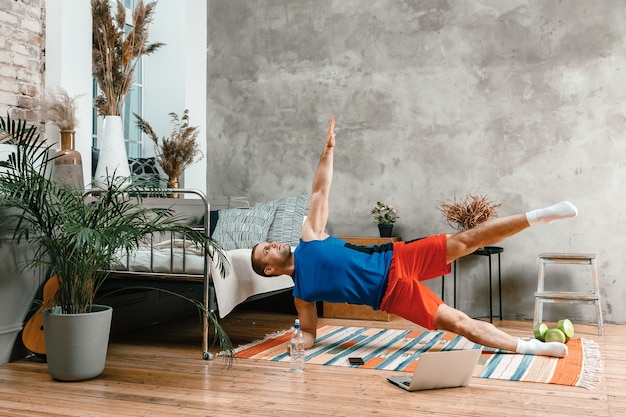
435,304,567,358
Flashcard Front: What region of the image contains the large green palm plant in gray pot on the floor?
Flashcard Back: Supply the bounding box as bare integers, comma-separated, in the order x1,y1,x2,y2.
0,117,232,381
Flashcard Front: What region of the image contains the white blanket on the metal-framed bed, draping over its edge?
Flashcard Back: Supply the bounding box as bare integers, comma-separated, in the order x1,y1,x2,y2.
114,239,293,318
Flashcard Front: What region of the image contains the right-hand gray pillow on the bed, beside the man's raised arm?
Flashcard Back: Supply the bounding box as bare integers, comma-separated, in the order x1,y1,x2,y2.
255,194,309,246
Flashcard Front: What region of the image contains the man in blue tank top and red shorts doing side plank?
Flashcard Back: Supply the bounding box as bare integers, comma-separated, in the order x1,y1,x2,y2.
252,115,578,357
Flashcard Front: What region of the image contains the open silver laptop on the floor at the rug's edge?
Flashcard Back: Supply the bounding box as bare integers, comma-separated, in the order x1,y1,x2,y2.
387,349,482,391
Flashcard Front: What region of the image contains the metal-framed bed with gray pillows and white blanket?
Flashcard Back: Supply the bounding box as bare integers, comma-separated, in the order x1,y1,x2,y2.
101,189,308,359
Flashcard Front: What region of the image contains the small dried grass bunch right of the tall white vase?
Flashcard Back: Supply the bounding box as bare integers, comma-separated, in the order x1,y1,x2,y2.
133,109,202,180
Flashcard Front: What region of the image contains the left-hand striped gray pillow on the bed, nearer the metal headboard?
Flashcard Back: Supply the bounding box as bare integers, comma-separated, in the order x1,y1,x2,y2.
212,204,276,250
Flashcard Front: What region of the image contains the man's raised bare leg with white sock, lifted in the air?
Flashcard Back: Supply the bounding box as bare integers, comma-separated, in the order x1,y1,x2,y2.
446,201,578,263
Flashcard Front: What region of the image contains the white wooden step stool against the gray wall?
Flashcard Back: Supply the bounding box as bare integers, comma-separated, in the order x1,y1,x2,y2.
534,253,602,336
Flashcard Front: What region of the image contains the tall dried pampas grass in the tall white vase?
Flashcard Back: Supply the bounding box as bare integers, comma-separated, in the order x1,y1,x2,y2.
91,0,164,116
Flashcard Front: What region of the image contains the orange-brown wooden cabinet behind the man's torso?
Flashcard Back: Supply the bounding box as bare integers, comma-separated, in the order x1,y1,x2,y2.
324,236,402,321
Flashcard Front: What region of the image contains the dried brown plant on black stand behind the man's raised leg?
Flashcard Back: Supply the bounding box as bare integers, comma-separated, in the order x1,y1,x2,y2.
439,193,502,230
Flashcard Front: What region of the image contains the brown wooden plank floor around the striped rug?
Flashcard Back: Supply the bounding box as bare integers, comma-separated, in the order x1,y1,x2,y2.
0,311,626,417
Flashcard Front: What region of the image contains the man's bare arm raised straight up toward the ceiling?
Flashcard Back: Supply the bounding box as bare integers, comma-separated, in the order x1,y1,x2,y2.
301,114,335,241
